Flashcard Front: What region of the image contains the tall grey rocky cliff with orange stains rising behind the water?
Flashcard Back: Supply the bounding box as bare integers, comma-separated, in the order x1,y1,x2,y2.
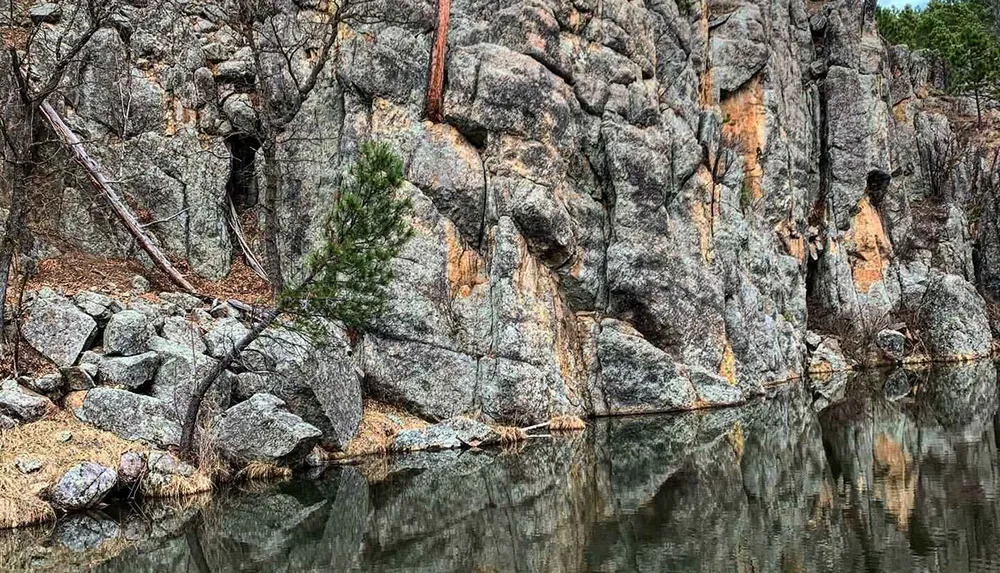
7,0,1000,423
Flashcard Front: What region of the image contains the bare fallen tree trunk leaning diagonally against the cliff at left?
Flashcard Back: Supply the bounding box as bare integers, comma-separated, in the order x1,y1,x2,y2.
41,102,200,296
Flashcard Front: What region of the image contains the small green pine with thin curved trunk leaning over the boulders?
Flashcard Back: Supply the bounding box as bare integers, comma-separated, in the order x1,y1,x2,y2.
180,142,412,456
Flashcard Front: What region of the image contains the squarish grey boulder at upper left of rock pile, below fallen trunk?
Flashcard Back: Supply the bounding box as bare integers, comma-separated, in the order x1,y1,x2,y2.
21,293,97,367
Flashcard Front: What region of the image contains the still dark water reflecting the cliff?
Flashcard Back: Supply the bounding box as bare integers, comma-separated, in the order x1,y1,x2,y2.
0,363,1000,573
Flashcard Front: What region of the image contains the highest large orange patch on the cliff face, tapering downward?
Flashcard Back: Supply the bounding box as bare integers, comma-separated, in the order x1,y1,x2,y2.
720,75,767,200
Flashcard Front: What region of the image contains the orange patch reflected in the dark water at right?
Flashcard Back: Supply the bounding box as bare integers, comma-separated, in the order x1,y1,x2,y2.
872,434,917,531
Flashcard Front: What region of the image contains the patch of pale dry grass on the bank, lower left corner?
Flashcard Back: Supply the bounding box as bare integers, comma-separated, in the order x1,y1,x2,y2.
0,411,149,529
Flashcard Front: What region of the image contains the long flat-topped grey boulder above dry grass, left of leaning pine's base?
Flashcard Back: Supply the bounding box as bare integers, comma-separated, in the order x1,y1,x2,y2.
76,388,181,447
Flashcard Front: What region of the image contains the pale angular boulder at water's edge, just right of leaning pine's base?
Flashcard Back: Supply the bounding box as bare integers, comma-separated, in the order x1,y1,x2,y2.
214,394,323,465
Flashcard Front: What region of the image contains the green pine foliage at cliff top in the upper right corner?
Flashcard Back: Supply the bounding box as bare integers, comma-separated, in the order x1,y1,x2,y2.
876,0,1000,119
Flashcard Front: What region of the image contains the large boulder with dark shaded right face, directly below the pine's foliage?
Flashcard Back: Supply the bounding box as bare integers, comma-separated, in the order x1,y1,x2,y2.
243,327,362,449
